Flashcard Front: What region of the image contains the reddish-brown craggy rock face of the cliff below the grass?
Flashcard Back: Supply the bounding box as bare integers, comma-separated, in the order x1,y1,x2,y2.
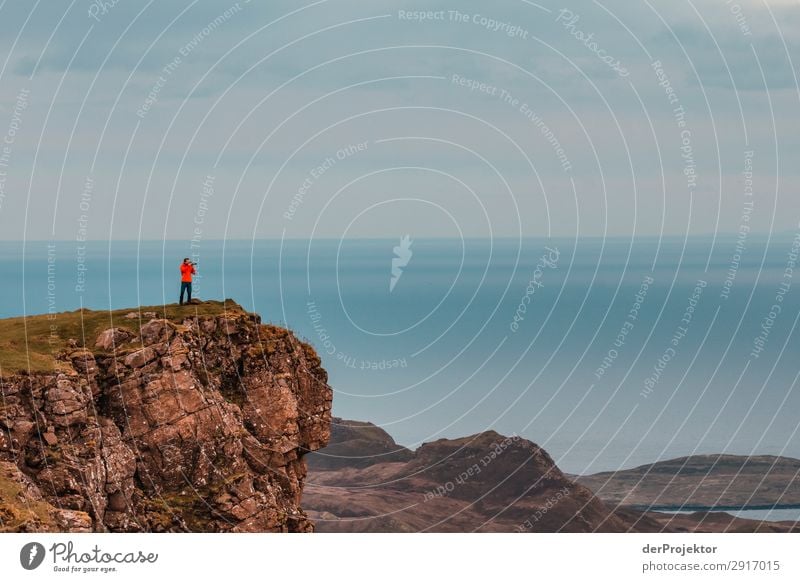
0,306,332,532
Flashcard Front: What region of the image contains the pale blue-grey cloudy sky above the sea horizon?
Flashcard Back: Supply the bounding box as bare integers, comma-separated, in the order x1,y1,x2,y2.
0,0,800,240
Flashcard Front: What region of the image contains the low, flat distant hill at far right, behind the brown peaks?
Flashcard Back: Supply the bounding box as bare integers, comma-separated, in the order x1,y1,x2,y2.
576,455,800,509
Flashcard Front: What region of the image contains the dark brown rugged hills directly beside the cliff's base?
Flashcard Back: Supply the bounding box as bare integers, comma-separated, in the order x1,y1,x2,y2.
303,418,797,532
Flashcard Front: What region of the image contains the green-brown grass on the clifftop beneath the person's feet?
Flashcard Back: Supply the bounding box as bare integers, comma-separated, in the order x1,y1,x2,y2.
0,299,245,377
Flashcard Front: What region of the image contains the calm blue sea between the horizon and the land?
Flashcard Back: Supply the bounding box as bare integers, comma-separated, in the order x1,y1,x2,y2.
0,233,800,473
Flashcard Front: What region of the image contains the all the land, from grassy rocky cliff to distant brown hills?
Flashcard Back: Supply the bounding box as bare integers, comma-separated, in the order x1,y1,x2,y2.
0,301,800,532
